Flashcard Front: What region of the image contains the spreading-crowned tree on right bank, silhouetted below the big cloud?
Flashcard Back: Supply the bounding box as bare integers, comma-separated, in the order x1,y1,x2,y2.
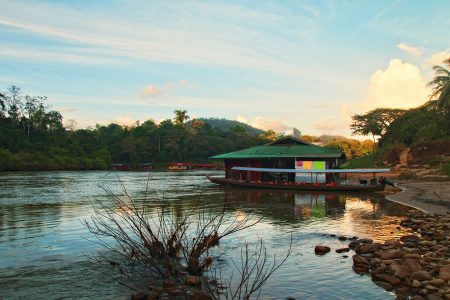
350,108,406,144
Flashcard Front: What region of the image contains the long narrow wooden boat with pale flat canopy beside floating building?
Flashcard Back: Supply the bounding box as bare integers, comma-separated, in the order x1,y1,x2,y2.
207,167,390,192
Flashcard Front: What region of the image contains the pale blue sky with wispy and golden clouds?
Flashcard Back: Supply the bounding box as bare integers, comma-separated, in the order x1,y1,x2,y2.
0,0,450,136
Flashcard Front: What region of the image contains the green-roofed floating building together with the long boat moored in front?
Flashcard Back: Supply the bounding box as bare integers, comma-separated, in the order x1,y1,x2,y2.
208,136,389,191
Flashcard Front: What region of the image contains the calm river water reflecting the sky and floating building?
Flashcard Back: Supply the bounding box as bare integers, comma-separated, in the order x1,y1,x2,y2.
0,171,409,299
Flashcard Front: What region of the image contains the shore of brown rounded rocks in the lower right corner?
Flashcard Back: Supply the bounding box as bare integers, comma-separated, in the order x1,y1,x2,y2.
348,212,450,300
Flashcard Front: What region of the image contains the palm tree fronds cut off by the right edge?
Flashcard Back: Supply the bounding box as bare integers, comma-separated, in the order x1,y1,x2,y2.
428,58,450,111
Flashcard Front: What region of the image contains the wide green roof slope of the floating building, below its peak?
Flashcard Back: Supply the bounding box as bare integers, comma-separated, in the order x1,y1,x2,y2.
210,144,343,159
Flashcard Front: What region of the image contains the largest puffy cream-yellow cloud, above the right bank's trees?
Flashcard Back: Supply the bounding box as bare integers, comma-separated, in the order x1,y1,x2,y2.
360,58,430,110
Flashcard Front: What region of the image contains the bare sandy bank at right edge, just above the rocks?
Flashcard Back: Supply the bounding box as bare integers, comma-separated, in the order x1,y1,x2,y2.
386,181,450,214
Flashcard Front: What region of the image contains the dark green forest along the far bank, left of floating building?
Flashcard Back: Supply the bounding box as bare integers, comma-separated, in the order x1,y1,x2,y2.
0,86,270,171
